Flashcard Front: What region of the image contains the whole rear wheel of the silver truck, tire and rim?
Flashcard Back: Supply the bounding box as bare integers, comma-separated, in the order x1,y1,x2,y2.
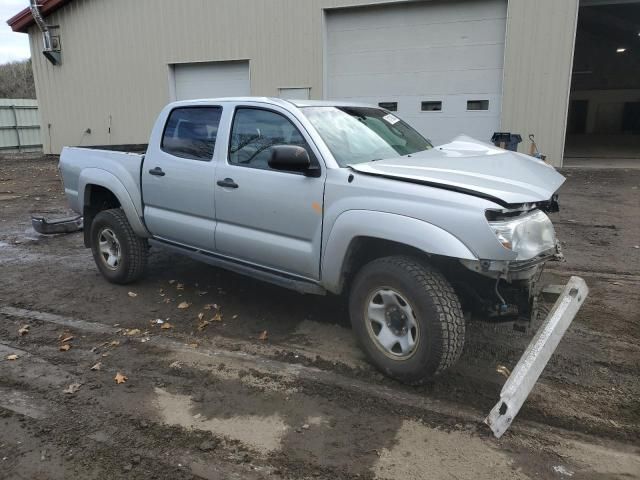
91,208,148,284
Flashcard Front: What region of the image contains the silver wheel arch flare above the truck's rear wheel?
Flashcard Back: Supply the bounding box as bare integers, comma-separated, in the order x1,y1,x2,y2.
78,168,150,238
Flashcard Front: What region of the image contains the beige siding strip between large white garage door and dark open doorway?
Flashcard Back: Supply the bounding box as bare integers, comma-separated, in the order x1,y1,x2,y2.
502,0,579,166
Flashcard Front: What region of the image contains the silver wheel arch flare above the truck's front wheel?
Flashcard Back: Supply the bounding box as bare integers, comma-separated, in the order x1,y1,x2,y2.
321,210,477,293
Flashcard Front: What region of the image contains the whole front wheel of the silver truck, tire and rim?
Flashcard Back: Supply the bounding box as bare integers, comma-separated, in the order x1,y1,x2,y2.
349,256,465,384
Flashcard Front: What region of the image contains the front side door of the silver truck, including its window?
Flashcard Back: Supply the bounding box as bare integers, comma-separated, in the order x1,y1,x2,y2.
215,105,326,280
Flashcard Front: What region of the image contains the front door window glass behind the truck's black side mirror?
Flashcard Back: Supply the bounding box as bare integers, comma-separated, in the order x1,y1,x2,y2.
229,108,315,169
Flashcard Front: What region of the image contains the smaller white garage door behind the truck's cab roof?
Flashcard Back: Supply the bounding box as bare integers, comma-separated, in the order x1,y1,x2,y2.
173,61,251,100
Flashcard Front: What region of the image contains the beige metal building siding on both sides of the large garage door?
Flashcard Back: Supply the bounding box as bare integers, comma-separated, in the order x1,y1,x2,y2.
30,0,578,165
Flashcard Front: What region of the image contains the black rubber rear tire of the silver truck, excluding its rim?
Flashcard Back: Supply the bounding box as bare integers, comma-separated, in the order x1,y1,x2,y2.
91,208,149,285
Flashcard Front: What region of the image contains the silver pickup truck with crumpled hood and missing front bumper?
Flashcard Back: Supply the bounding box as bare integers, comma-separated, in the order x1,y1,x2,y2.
60,98,586,436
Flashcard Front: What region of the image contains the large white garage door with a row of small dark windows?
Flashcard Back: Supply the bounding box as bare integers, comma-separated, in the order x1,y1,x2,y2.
326,0,507,144
